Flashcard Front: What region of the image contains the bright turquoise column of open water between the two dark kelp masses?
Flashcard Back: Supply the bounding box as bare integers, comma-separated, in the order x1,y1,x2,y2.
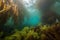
24,0,41,26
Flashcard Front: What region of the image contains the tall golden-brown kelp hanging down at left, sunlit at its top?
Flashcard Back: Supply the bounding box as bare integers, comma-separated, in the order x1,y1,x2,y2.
0,0,18,38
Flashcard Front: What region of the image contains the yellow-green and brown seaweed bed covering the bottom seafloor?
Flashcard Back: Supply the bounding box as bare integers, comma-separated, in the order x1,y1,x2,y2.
0,23,60,40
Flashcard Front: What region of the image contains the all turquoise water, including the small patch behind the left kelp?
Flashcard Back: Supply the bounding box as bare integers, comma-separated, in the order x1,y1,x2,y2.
5,0,41,27
